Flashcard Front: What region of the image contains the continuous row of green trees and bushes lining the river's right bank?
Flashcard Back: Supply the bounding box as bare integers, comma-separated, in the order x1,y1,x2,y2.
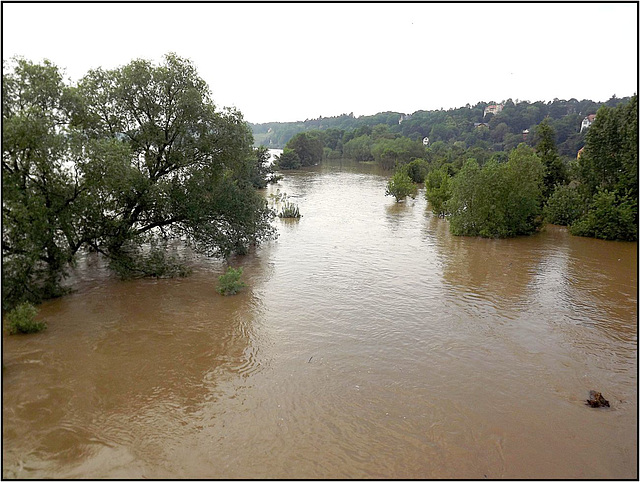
268,95,638,241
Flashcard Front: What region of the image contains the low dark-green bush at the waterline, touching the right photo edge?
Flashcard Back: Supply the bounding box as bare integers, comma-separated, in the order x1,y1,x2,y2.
570,190,638,241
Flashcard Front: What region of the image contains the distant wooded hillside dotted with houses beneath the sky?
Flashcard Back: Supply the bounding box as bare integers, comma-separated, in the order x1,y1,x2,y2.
249,95,629,158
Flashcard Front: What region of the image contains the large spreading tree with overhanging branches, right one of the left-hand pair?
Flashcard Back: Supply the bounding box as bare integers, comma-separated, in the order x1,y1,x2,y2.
76,54,271,266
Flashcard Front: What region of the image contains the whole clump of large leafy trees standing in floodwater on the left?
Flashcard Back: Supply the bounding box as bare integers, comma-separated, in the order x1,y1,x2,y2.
2,54,274,308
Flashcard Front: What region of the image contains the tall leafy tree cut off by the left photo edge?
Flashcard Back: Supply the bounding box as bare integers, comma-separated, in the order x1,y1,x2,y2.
2,58,91,308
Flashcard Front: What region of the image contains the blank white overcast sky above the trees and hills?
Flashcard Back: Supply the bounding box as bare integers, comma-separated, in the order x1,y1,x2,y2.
2,3,638,122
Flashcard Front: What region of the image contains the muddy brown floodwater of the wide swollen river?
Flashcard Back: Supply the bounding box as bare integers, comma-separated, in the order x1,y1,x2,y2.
2,159,638,479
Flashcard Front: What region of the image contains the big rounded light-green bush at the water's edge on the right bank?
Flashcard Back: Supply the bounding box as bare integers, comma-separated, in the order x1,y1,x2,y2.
447,144,543,238
